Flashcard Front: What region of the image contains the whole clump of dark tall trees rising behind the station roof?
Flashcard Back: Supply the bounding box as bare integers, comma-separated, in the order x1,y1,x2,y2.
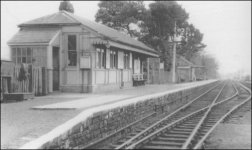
96,1,206,70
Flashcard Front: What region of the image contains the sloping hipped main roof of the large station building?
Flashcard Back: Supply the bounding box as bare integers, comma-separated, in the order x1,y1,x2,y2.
19,11,157,54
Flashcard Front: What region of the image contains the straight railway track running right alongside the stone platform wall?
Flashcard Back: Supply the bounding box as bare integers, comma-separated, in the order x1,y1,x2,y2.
82,83,221,149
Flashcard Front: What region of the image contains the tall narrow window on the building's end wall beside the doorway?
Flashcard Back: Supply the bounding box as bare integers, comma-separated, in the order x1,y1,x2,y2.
68,35,77,66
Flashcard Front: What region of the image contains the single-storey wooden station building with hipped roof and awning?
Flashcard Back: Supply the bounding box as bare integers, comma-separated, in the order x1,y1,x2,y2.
8,11,158,93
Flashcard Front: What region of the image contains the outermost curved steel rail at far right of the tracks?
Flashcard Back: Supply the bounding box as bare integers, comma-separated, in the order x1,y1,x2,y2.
193,83,251,149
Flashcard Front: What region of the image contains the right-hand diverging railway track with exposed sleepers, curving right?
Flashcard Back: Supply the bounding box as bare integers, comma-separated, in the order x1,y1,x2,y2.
105,81,250,149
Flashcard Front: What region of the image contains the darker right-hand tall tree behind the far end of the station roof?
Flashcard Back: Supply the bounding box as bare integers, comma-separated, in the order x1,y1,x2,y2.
141,1,189,70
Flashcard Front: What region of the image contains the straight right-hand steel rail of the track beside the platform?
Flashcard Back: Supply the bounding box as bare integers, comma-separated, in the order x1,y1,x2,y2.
115,83,221,149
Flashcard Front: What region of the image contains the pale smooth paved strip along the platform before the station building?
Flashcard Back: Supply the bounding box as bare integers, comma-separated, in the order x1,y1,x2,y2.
32,80,216,109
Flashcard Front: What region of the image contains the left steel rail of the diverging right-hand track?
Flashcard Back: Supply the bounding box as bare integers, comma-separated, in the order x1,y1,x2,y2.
126,81,237,149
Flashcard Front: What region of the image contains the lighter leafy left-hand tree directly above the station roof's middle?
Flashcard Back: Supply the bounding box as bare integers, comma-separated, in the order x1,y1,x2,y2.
95,1,146,37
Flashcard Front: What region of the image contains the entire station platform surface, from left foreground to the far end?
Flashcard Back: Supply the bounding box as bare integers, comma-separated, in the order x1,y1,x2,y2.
1,80,216,149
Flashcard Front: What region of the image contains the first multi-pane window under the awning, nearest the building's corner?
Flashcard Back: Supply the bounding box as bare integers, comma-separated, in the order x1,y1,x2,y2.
96,48,106,68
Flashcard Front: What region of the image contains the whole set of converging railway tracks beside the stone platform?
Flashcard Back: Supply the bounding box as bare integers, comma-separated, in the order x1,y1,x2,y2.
83,82,251,149
